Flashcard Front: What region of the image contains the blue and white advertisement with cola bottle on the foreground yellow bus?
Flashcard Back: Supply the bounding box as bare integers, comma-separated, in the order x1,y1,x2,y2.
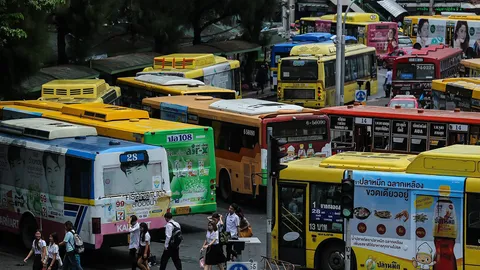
350,171,465,269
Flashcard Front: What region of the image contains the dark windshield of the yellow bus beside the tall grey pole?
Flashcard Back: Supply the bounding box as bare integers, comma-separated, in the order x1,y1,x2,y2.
280,59,318,81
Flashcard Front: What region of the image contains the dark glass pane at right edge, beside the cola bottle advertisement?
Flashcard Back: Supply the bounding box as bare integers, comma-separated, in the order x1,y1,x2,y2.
465,193,480,246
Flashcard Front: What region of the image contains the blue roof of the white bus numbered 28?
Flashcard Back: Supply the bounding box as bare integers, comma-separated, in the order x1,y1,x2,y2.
0,125,160,159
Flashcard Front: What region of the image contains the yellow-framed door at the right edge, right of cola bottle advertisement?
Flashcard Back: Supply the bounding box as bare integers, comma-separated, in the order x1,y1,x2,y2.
464,190,480,270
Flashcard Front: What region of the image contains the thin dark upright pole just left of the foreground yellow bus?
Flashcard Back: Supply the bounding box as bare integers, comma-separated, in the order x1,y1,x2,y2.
266,127,273,258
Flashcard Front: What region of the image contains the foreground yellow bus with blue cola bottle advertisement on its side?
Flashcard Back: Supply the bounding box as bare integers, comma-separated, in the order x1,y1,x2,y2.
271,145,480,270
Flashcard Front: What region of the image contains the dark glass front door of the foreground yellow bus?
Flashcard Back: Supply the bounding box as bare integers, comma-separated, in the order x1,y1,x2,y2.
277,183,307,265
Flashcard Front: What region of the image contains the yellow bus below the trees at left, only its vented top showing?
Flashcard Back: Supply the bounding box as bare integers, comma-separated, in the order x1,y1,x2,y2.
39,79,122,105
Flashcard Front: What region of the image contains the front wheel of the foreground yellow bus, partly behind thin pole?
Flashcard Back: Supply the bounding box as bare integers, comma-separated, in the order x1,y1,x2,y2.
315,240,357,270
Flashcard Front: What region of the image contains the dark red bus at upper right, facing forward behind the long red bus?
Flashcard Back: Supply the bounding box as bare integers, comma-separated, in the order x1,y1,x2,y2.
392,45,463,100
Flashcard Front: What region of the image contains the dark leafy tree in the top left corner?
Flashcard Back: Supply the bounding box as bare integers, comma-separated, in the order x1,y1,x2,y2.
0,0,63,98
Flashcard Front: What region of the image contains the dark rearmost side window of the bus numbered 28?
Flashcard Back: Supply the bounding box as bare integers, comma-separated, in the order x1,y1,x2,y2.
65,156,92,199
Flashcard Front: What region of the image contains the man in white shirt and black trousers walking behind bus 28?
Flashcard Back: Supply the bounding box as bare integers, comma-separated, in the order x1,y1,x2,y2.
160,212,182,270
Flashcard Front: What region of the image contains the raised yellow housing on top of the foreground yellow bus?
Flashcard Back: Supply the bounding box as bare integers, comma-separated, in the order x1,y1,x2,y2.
407,144,480,178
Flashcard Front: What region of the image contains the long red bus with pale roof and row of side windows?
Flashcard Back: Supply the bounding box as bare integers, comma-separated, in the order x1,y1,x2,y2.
320,105,480,154
